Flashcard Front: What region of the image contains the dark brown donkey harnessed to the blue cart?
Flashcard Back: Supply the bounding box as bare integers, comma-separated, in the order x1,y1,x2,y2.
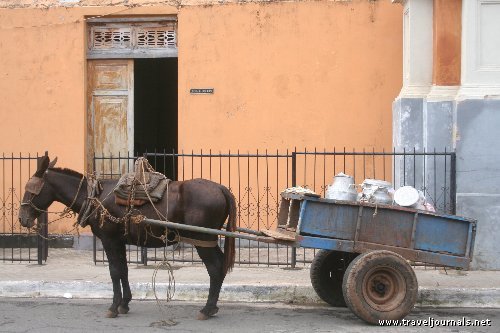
19,156,236,319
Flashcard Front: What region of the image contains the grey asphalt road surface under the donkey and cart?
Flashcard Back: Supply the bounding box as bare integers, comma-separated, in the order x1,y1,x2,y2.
0,298,500,333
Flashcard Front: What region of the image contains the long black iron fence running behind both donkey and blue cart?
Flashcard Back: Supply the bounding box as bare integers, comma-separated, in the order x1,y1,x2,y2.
94,149,456,267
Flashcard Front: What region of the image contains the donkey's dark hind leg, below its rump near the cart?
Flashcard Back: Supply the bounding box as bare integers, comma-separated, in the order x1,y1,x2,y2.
196,246,225,320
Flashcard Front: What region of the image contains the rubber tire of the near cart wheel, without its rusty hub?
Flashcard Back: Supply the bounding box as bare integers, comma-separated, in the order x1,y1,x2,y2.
342,250,418,325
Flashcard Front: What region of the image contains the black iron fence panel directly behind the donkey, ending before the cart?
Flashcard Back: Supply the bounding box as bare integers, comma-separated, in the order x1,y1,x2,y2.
94,151,292,266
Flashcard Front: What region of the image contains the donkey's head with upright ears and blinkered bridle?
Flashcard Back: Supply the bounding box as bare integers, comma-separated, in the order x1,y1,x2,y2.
19,155,57,228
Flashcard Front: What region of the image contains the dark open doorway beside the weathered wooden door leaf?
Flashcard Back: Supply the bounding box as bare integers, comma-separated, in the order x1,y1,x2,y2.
134,58,178,179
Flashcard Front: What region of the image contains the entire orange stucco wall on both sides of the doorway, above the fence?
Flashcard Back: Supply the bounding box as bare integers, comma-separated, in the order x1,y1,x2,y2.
0,0,402,232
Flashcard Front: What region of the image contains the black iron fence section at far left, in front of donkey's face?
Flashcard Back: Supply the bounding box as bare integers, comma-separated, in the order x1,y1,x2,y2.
0,154,48,264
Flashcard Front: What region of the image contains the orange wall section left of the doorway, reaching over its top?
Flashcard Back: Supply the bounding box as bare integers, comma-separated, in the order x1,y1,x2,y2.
0,6,176,171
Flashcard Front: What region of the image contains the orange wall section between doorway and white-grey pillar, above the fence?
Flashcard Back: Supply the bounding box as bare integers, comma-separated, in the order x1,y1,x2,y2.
179,1,402,150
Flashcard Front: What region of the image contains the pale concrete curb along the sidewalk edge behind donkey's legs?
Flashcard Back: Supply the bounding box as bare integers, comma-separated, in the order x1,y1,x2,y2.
0,281,500,308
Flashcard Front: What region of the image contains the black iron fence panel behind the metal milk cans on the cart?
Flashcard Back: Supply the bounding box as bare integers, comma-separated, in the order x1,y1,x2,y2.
292,149,456,214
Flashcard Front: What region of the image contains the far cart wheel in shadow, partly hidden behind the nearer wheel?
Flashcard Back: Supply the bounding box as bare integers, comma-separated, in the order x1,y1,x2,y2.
310,250,357,307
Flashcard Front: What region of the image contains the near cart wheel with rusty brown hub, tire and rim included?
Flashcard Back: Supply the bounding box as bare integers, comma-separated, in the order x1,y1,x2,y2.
342,251,418,324
